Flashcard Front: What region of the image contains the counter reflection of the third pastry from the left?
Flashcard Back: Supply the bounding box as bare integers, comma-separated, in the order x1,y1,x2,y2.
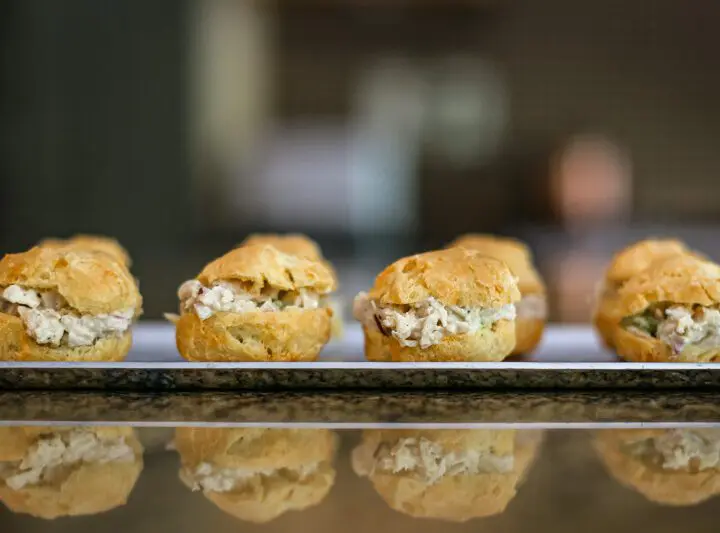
352,430,540,522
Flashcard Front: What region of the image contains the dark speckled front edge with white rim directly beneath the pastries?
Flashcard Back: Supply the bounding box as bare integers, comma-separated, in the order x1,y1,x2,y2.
0,363,720,391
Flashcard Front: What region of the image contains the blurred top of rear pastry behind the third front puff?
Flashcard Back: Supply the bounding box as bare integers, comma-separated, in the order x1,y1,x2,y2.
450,233,545,295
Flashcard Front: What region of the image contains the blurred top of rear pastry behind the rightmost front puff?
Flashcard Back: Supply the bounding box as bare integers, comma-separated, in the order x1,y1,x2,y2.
605,239,690,285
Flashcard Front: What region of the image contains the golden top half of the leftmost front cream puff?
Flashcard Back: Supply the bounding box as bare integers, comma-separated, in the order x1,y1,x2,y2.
0,247,142,315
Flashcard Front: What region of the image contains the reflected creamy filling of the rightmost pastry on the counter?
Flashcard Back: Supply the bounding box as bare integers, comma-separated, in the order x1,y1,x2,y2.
632,429,720,471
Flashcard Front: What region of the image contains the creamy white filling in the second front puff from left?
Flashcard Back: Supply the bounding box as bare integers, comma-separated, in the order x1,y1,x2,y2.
178,279,321,320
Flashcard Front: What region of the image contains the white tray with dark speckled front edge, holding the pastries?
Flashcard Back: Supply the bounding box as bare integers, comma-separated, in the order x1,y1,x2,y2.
0,324,720,391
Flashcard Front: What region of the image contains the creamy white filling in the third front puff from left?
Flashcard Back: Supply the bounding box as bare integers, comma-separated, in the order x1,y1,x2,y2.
353,292,516,349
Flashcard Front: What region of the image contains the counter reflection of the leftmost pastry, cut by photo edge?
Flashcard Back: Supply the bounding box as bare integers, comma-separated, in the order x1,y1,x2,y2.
0,427,143,519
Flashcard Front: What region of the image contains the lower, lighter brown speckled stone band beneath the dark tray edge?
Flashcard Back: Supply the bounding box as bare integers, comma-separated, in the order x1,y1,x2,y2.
0,391,720,426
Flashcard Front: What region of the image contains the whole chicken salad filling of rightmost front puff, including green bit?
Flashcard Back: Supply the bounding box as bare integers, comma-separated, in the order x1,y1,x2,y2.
622,305,720,355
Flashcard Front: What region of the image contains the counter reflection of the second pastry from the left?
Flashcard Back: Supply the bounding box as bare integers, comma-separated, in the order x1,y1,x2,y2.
175,428,337,523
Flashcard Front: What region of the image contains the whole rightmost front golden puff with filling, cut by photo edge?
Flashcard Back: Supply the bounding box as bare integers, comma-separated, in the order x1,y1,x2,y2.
614,255,720,363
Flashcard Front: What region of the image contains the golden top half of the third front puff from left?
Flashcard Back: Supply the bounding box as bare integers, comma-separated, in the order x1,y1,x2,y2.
368,248,520,308
